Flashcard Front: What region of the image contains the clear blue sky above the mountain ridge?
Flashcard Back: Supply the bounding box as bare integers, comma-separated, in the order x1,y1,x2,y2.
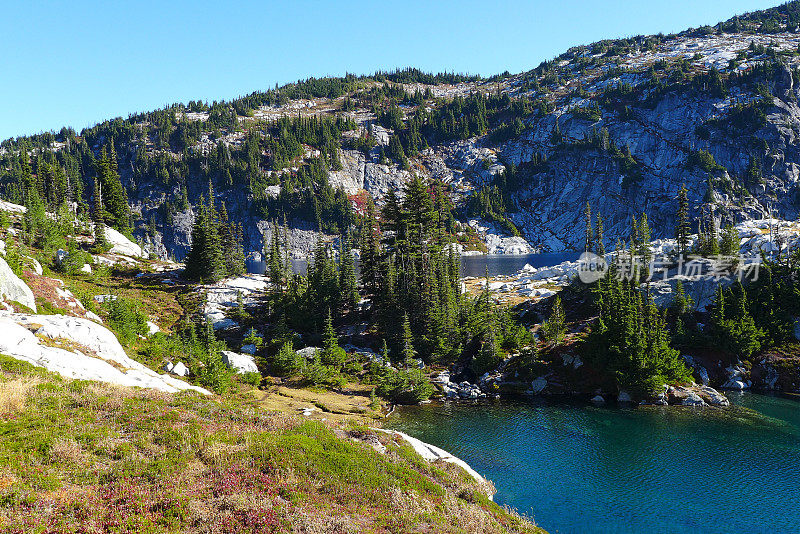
0,0,780,139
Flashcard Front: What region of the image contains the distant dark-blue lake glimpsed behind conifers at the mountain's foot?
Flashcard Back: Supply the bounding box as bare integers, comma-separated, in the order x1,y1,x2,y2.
247,252,580,276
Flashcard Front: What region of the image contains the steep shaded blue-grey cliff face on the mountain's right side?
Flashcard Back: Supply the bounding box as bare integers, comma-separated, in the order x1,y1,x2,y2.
498,71,800,250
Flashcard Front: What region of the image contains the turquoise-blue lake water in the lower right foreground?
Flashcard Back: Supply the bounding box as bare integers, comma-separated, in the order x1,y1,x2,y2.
387,393,800,534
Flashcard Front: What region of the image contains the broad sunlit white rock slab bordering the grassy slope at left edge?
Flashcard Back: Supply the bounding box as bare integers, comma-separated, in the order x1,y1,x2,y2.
0,313,209,394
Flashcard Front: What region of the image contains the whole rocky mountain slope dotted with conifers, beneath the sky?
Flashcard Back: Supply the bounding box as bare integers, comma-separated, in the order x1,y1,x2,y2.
0,2,800,259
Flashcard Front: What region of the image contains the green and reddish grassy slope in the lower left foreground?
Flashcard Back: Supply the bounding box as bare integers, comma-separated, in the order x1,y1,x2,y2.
0,356,538,533
